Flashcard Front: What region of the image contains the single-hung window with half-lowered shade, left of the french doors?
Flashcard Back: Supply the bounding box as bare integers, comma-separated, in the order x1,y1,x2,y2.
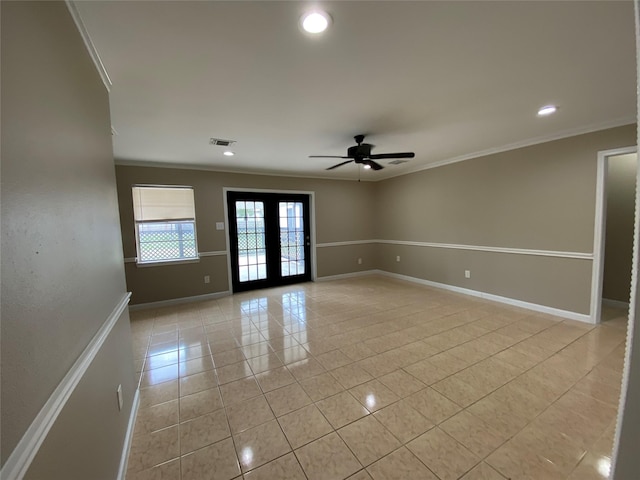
132,186,198,264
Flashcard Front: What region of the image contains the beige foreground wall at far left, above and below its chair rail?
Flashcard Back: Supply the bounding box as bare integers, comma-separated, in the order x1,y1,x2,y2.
0,2,134,479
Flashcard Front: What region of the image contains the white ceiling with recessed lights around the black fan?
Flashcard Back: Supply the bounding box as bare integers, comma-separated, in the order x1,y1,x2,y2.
75,1,636,180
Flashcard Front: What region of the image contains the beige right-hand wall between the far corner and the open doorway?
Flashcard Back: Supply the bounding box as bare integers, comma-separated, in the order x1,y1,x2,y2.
375,125,636,314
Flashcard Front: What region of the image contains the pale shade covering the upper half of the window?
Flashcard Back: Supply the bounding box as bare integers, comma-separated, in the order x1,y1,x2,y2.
132,187,196,222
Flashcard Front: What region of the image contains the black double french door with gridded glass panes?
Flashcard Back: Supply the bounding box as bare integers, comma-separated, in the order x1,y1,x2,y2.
227,192,311,292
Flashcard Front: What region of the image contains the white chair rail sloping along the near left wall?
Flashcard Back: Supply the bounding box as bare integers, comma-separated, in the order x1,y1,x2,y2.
0,293,131,480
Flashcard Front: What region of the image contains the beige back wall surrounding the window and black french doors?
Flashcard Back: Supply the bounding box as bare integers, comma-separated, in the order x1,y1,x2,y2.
116,165,375,304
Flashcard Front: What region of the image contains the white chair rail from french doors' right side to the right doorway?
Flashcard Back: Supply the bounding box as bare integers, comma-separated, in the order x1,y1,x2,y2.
316,239,593,260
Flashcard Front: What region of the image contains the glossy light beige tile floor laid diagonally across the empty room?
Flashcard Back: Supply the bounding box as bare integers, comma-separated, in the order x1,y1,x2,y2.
127,276,626,480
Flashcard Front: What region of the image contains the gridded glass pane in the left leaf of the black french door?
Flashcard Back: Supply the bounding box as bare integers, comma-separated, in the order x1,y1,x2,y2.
236,200,267,282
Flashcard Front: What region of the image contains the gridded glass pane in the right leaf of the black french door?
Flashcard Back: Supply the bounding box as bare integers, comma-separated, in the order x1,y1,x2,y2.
278,202,305,277
